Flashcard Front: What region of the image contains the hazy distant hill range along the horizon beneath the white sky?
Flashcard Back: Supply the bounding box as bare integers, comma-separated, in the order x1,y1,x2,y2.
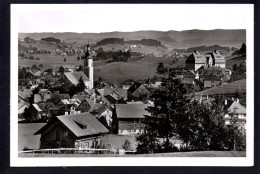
19,29,246,48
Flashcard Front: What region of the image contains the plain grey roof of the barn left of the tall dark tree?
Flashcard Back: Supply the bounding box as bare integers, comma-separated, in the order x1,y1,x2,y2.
116,104,152,118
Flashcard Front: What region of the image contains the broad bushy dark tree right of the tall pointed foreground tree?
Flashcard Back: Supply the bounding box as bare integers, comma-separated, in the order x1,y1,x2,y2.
176,101,229,150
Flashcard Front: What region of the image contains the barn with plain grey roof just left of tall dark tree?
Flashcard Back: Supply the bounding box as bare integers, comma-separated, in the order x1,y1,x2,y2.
115,104,152,134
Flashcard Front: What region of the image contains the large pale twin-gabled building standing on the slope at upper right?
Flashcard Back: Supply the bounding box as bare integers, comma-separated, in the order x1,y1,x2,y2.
186,50,226,71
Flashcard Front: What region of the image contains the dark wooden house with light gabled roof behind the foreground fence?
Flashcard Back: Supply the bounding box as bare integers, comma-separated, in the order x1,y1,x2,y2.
34,112,109,149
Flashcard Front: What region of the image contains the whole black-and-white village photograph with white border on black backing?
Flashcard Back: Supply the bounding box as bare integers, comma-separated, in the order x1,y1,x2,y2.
10,4,254,166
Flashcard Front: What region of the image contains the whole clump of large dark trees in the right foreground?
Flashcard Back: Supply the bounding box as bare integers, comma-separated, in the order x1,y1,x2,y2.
136,77,246,153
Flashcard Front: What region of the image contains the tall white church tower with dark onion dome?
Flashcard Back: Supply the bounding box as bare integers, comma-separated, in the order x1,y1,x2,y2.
83,43,94,89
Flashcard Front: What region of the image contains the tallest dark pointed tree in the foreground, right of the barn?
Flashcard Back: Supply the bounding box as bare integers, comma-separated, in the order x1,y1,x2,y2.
144,77,188,149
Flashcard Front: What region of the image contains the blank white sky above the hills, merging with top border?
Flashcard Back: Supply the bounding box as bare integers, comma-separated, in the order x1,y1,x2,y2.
11,4,253,33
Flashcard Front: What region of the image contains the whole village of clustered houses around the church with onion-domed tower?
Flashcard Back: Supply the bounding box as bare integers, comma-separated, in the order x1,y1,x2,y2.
18,39,246,154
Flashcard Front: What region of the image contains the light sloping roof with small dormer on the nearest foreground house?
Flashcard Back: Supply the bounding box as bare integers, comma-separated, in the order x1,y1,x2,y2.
35,112,109,137
